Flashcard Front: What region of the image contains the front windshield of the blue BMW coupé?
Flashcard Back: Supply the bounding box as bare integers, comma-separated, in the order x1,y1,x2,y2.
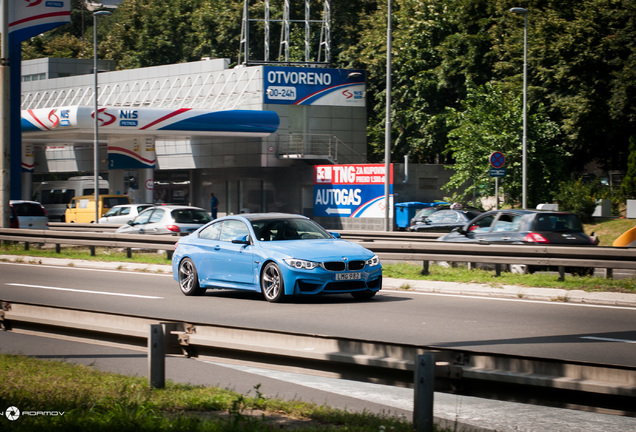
251,219,332,241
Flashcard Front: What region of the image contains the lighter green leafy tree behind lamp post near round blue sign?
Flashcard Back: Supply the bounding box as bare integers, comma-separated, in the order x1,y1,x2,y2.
444,83,567,207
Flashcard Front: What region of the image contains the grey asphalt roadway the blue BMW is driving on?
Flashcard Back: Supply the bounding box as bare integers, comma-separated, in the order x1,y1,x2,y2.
0,263,636,367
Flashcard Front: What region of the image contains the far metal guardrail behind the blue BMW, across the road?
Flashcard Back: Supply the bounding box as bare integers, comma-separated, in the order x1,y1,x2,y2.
0,230,636,279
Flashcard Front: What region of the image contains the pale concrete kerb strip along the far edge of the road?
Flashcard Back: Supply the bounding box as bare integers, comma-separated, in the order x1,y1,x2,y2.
0,255,636,307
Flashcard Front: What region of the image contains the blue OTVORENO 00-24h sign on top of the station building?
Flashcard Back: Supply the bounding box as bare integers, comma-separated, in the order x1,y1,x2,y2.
263,66,366,107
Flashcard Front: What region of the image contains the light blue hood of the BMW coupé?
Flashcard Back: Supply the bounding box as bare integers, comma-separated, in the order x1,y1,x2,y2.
259,239,373,261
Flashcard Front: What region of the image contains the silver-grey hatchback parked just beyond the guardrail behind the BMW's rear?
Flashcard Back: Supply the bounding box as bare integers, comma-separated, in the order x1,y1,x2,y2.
115,205,212,235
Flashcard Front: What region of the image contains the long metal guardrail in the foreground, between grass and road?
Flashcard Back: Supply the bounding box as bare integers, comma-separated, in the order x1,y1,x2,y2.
0,301,636,417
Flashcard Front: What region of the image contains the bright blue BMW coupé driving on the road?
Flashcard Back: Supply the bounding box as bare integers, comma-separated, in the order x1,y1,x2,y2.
172,213,382,302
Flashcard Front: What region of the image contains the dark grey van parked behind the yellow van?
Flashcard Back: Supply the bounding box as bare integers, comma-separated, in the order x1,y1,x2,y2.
33,176,110,222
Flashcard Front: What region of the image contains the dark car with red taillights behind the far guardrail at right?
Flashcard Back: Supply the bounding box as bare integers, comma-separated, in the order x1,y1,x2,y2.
437,210,595,273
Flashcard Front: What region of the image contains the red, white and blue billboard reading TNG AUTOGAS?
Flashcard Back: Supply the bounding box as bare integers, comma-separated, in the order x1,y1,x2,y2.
314,164,393,218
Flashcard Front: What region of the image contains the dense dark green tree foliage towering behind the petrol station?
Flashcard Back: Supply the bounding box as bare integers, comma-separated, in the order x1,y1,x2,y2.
23,0,636,207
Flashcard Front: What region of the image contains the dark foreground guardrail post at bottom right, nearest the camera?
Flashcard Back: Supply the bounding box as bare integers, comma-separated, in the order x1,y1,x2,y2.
413,352,435,432
